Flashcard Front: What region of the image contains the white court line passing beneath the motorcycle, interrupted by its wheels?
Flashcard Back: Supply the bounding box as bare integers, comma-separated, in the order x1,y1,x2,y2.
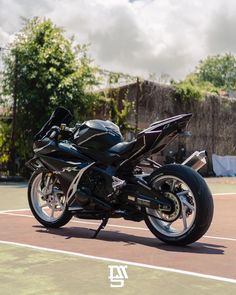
2,212,236,242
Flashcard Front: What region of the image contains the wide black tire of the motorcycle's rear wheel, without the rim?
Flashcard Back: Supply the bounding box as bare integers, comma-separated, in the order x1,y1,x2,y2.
145,164,214,246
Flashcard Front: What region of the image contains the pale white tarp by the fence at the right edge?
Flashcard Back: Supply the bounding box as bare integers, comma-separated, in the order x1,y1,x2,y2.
212,154,236,176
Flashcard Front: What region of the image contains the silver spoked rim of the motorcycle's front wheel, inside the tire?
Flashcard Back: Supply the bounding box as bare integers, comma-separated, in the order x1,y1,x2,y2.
31,173,66,222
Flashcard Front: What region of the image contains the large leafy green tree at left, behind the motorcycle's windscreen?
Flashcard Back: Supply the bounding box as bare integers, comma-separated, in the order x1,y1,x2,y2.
2,17,97,164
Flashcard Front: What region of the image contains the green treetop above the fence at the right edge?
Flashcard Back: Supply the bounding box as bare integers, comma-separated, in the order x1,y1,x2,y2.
196,53,236,90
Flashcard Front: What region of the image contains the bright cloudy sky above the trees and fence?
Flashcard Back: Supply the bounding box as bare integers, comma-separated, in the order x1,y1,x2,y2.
0,0,236,79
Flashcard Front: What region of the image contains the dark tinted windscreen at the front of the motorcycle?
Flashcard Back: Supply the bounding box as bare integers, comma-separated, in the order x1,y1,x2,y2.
34,107,73,140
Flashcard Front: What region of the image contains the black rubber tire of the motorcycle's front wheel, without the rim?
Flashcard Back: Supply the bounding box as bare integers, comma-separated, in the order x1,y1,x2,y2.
28,169,72,228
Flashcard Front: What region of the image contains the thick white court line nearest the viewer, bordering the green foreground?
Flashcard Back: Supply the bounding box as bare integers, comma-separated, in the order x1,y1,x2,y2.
0,240,236,284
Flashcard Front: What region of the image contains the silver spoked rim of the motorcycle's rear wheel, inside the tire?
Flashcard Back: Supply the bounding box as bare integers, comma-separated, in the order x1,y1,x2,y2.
146,175,197,237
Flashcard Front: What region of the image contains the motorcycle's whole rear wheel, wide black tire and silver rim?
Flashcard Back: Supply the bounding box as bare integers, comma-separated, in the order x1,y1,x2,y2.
145,164,214,246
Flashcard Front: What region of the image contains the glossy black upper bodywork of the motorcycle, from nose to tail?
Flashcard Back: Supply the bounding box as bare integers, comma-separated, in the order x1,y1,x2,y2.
34,114,191,169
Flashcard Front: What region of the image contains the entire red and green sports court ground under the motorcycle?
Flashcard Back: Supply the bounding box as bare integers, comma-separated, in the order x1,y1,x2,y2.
0,181,236,294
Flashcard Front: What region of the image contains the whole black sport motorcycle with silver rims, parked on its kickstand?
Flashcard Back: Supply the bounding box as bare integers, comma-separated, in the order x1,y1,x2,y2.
27,107,213,245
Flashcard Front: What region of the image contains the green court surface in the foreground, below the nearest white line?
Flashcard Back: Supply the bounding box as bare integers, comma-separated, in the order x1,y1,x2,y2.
0,244,236,295
